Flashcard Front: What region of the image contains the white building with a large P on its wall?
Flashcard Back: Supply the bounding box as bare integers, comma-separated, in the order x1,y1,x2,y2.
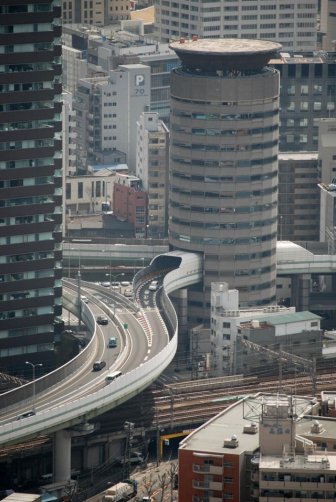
74,64,150,173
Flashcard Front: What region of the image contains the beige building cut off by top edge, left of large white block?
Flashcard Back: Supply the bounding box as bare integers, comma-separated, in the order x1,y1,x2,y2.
62,0,130,26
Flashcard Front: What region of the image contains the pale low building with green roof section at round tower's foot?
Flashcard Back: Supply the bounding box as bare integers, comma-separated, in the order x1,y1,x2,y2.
210,283,323,376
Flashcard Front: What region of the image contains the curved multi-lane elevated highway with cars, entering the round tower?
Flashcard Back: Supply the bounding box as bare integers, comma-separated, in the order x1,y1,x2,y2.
0,252,202,481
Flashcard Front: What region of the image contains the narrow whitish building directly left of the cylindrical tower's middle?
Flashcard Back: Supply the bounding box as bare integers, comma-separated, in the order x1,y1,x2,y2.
136,112,169,238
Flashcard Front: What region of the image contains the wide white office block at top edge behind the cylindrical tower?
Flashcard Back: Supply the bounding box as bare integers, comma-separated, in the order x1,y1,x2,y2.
154,0,318,51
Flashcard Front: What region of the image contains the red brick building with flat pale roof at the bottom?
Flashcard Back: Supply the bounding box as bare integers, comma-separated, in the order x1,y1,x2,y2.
179,403,259,502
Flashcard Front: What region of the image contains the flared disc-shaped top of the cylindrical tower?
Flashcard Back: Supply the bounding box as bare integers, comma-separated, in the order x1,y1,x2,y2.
169,36,282,72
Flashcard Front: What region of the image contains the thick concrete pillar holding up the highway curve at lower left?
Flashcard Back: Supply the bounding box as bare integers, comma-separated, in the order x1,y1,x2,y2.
54,430,71,483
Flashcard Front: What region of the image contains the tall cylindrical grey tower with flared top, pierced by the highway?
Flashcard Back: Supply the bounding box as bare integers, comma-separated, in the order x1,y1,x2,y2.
169,39,281,320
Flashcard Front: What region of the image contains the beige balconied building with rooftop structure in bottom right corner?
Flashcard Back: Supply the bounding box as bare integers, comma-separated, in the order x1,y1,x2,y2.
258,399,336,502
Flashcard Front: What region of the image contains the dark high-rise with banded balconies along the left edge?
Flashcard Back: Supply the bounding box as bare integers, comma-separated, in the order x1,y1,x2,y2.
0,0,62,371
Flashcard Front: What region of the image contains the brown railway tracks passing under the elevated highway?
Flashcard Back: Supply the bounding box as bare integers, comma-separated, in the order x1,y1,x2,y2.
0,372,336,458
